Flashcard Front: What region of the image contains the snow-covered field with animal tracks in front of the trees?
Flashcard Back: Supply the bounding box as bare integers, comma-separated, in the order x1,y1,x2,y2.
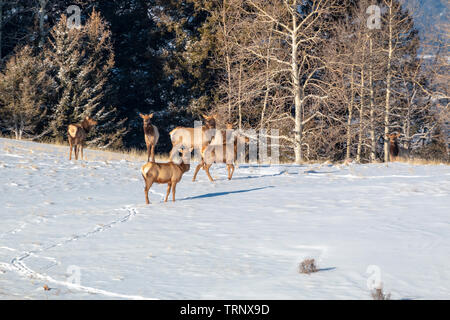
0,139,450,299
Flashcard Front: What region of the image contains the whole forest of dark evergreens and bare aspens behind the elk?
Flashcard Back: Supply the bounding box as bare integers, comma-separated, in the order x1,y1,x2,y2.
0,0,450,163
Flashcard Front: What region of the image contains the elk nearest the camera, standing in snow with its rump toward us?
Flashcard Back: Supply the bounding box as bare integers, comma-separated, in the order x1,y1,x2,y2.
141,152,191,204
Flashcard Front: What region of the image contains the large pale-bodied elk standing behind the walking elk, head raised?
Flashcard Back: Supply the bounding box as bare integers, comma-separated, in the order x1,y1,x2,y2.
170,114,217,159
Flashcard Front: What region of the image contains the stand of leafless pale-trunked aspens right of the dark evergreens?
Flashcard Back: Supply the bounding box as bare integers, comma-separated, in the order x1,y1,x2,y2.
211,0,445,163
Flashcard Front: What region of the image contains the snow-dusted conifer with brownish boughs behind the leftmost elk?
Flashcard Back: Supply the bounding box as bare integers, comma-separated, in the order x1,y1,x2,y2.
44,11,125,146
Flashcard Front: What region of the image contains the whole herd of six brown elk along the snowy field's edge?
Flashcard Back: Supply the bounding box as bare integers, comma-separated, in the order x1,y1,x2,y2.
67,113,408,204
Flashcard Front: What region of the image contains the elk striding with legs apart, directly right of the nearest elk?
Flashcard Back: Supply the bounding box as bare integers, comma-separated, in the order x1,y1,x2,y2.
192,124,249,182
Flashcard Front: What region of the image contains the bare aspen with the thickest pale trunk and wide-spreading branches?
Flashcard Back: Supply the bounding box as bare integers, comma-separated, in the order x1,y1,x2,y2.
230,0,337,163
